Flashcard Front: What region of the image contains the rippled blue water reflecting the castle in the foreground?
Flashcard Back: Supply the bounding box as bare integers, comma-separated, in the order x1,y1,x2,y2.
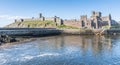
0,35,120,65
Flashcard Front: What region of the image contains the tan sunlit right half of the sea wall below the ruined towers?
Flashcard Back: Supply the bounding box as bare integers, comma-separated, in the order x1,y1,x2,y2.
61,29,120,35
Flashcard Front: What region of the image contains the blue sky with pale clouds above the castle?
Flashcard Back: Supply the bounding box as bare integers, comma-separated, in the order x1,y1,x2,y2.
0,0,120,27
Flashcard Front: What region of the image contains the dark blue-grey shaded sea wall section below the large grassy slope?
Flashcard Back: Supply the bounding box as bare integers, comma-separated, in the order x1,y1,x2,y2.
0,28,61,36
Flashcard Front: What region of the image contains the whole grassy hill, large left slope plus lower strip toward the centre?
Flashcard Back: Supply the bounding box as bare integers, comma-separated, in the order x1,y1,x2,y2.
5,20,78,29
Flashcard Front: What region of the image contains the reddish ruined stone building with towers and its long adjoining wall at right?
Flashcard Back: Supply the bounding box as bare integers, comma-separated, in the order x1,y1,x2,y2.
63,11,112,29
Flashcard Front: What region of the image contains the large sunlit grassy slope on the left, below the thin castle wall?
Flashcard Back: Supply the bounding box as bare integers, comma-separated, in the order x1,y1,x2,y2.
8,20,56,28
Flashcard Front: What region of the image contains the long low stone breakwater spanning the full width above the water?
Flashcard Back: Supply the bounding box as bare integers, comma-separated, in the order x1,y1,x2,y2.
0,28,120,36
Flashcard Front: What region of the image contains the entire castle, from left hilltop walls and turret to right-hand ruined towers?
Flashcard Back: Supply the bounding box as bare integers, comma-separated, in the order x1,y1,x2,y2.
15,11,112,29
